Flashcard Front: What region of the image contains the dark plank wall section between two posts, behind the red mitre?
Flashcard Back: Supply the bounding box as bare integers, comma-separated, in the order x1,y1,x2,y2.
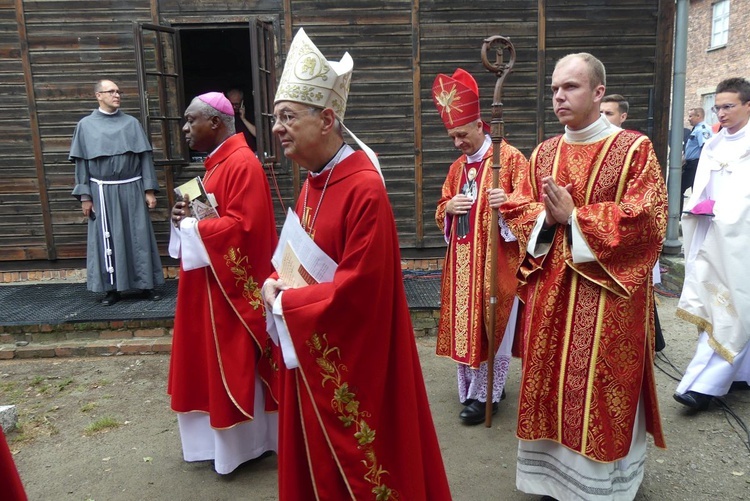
420,0,538,247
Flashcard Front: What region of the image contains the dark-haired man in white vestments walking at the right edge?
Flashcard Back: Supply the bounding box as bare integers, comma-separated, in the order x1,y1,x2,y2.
674,78,750,410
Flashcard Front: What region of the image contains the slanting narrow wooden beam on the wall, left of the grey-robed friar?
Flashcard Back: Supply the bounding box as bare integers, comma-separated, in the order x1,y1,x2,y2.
15,0,57,261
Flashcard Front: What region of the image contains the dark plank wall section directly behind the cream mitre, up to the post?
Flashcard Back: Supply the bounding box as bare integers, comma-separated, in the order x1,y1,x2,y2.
284,0,424,247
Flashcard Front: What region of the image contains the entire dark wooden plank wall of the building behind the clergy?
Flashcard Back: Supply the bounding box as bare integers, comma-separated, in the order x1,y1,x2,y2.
0,0,672,262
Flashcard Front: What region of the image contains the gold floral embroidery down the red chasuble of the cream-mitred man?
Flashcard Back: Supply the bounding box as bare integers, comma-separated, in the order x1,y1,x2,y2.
306,334,399,501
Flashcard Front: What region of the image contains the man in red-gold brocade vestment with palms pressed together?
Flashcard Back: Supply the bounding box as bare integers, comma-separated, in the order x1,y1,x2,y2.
500,53,666,500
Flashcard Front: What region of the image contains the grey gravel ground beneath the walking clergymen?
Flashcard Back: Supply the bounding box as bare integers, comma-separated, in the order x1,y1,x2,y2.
0,297,750,501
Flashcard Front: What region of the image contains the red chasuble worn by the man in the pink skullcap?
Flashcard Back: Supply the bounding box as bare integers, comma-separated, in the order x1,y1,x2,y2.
168,134,278,429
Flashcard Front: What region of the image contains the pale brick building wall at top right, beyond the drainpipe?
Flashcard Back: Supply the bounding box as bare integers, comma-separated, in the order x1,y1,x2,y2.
684,0,750,122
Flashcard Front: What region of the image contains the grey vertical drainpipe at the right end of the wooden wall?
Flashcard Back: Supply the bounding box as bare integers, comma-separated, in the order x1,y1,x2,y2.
663,0,689,254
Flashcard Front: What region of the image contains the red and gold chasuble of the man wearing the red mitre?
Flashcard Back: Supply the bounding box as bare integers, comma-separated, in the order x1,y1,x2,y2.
435,143,531,369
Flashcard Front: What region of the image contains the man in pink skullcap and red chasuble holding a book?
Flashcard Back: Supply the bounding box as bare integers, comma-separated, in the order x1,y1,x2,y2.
167,92,278,474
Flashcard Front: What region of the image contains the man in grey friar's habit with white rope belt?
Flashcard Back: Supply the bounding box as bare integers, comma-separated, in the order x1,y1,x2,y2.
68,80,164,306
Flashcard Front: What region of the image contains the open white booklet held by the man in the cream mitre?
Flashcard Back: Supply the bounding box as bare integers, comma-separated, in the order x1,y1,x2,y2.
271,209,338,288
